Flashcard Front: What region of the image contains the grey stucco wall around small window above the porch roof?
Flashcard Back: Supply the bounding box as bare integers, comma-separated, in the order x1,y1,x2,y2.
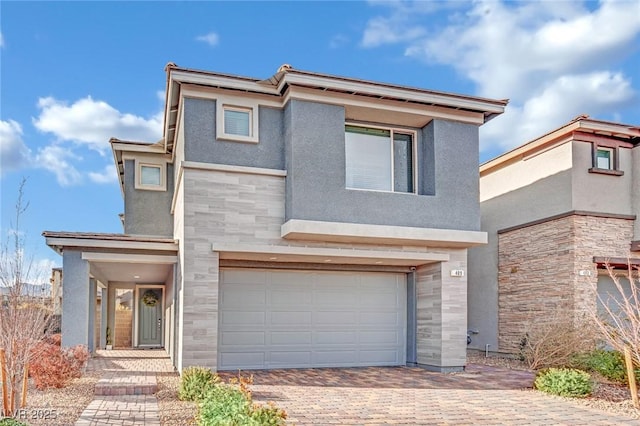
124,160,174,236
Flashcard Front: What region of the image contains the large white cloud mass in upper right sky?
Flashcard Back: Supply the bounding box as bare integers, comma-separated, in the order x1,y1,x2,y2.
363,0,640,150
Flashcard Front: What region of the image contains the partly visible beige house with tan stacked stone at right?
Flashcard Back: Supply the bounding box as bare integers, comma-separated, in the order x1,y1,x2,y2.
468,116,640,353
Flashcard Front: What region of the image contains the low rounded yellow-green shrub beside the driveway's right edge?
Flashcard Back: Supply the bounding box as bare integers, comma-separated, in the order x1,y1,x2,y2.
534,368,593,397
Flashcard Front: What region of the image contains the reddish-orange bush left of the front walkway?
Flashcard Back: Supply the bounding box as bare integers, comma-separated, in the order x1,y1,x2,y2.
29,342,89,389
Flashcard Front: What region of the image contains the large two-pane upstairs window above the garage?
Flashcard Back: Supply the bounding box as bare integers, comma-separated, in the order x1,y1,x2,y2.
345,125,415,192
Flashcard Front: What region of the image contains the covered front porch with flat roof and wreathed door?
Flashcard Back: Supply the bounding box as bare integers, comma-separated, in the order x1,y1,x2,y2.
43,232,178,359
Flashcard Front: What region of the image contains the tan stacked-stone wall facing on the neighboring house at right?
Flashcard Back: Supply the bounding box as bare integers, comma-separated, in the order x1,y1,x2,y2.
498,215,633,353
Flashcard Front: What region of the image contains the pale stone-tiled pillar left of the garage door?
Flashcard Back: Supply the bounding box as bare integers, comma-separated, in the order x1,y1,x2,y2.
178,243,219,371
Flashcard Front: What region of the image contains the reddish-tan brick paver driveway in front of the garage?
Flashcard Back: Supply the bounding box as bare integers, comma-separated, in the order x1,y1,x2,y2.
219,365,640,425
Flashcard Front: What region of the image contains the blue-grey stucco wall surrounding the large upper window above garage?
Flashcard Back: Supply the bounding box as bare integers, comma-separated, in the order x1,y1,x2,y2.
284,100,480,231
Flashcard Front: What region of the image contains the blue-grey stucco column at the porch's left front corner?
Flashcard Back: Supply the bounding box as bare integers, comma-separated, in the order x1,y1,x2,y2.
62,250,93,347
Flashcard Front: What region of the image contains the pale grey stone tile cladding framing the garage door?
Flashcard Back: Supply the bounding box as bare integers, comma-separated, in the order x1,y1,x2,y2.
174,168,467,370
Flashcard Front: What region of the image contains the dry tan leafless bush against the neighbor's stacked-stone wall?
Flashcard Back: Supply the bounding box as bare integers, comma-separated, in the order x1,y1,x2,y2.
520,310,598,370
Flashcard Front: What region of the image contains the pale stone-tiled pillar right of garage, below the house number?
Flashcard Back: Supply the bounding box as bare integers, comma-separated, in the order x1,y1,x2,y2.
416,250,467,372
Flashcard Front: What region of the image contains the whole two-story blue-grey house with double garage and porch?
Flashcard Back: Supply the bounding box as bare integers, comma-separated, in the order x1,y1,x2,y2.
43,64,506,371
